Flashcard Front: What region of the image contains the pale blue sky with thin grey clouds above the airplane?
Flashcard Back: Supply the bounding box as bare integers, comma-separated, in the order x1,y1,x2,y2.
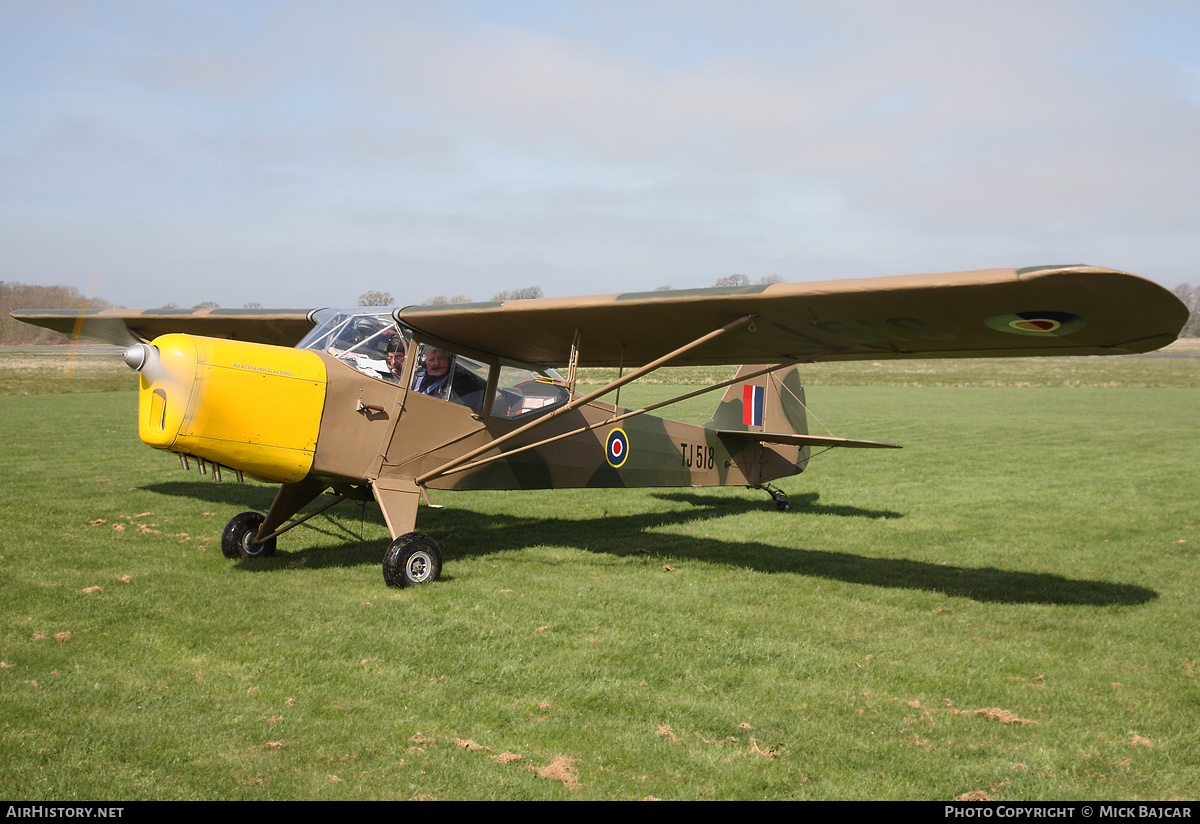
0,0,1200,308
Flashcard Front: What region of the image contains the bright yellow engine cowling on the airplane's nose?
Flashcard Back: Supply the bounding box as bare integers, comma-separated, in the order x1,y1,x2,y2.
136,335,326,483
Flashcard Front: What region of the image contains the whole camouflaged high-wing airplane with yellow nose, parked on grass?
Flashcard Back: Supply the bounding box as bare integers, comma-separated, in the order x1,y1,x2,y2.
12,265,1188,587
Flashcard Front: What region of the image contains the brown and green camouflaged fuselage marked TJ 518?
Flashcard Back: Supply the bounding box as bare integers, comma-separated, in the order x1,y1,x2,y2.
312,356,808,489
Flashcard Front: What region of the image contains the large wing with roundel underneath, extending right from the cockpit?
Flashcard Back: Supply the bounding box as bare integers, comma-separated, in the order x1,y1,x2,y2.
397,265,1188,367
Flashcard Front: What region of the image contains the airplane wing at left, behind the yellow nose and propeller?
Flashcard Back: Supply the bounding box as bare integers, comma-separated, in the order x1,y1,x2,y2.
12,309,312,347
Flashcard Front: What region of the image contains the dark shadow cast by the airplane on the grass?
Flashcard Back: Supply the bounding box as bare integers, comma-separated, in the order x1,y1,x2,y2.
145,482,1158,606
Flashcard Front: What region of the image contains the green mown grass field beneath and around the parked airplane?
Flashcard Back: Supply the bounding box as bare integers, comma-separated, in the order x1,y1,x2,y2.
0,342,1200,800
